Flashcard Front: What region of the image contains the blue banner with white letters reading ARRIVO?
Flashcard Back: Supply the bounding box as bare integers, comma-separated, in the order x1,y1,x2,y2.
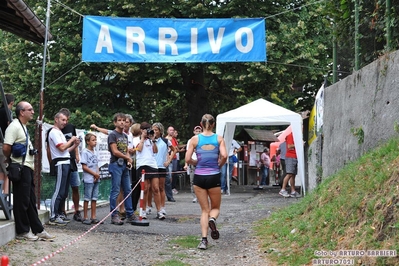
82,16,266,63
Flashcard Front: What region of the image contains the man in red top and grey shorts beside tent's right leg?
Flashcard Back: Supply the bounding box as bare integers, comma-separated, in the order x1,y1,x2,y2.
279,133,300,198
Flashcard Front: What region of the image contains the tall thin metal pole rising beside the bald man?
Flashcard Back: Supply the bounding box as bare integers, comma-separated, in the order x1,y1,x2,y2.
34,0,51,210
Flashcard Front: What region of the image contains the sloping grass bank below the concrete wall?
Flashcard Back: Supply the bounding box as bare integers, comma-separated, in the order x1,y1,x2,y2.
255,136,399,265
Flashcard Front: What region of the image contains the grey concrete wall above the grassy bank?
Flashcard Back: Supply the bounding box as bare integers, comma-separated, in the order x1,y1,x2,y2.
307,51,399,189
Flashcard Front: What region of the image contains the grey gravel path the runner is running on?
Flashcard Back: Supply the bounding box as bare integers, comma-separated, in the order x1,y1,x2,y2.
0,190,295,265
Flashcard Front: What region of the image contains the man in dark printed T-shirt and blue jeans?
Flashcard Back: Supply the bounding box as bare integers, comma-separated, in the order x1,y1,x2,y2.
108,113,135,225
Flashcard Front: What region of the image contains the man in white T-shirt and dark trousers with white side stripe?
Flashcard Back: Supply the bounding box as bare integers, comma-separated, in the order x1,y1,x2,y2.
48,112,80,225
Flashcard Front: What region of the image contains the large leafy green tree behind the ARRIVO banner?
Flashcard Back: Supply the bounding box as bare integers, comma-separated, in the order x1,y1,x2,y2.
0,0,331,139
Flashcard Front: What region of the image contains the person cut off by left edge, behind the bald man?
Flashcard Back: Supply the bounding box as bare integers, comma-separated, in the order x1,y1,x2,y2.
0,93,15,195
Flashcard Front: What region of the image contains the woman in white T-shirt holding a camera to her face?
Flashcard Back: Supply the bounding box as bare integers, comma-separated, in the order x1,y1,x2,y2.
135,122,161,219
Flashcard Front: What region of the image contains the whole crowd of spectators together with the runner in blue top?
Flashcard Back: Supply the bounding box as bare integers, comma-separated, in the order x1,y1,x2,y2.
0,95,299,249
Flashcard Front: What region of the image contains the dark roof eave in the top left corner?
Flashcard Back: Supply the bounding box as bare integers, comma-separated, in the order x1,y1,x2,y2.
0,0,52,44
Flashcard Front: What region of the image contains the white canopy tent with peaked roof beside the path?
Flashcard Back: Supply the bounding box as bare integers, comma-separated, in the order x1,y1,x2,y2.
216,99,306,194
